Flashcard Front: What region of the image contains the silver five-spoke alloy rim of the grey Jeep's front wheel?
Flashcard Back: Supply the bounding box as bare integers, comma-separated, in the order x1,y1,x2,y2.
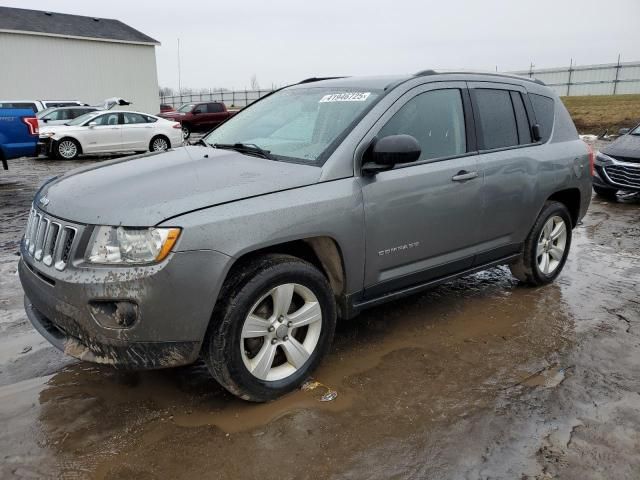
240,283,322,381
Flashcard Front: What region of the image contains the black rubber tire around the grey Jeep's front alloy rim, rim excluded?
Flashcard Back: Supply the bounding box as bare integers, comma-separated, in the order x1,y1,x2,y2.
202,254,336,402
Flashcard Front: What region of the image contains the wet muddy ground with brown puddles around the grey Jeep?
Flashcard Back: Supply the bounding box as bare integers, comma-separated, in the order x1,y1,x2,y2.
0,148,640,480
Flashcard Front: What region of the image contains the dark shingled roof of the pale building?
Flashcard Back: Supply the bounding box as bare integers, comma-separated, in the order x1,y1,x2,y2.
0,7,160,45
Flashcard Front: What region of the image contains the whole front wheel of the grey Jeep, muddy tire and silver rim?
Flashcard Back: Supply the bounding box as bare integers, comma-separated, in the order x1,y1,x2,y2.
202,254,336,402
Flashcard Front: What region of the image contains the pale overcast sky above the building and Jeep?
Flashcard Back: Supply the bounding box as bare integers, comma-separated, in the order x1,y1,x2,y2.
5,0,640,88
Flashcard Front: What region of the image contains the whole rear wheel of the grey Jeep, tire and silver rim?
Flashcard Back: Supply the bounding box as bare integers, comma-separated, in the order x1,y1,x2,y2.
509,202,572,286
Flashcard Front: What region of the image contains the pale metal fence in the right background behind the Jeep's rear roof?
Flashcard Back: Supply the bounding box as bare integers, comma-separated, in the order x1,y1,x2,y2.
510,59,640,97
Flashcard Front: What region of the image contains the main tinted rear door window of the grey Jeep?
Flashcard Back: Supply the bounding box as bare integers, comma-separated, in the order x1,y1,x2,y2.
475,88,519,150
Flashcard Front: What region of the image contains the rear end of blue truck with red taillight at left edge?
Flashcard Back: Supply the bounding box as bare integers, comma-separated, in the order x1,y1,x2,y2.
0,108,38,170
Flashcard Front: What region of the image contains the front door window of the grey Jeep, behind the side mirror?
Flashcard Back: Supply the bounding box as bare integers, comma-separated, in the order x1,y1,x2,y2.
378,89,467,160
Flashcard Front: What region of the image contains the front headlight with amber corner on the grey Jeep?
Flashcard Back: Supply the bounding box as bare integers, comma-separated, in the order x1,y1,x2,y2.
87,227,180,265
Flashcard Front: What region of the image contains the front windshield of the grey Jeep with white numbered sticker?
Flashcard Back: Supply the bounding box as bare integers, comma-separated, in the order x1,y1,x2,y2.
203,87,380,164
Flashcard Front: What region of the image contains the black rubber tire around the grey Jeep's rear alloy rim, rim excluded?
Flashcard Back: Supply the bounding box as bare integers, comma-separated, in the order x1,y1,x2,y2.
509,201,572,286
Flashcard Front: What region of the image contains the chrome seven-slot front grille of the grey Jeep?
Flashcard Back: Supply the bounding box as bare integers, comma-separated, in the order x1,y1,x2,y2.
24,207,78,271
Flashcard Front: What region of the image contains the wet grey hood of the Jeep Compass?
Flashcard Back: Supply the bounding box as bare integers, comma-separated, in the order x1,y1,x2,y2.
34,146,321,226
